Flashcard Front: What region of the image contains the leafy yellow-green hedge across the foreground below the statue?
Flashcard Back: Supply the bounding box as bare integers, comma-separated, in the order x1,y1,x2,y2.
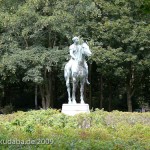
0,109,150,150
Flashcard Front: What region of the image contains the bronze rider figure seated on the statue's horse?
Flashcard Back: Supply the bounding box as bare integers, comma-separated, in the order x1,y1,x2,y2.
69,37,90,84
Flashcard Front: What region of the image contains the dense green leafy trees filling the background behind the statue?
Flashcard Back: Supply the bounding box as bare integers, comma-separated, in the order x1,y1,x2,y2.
0,0,150,111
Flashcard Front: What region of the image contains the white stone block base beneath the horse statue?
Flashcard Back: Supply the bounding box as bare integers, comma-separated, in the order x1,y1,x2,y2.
61,103,90,116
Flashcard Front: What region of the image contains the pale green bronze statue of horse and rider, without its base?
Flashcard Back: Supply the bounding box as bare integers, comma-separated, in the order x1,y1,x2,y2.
64,37,92,104
